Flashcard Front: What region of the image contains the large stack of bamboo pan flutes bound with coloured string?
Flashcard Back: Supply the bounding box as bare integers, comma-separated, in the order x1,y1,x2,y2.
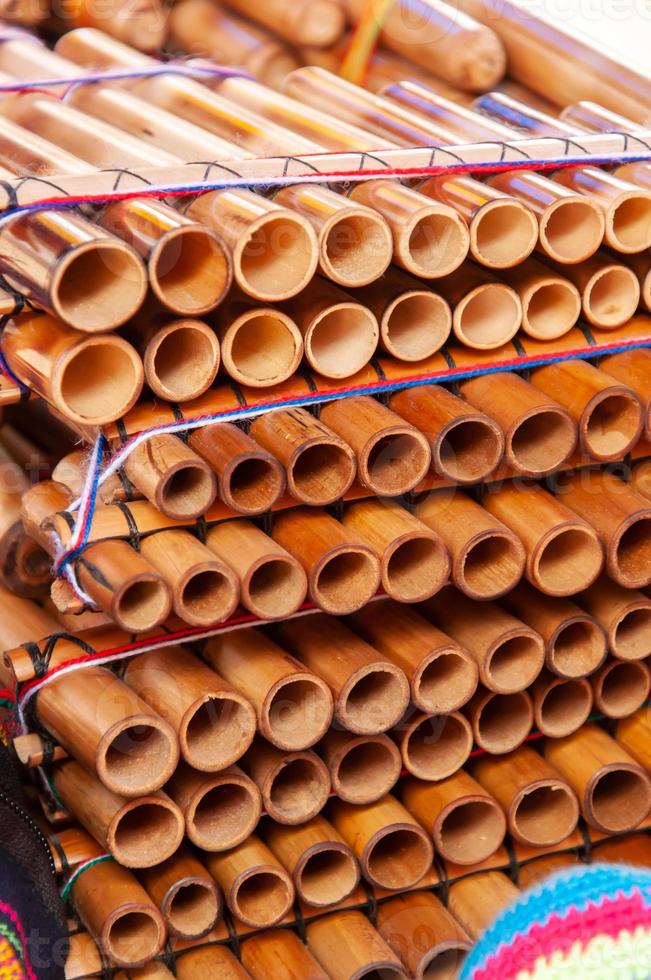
0,13,651,980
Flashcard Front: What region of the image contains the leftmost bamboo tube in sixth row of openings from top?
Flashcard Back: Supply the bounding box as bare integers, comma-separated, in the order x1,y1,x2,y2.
53,761,183,868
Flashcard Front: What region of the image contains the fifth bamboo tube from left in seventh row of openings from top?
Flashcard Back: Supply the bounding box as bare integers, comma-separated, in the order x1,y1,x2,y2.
330,795,433,889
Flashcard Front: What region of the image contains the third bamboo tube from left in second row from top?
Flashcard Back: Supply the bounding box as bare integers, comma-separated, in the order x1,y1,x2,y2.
217,296,303,388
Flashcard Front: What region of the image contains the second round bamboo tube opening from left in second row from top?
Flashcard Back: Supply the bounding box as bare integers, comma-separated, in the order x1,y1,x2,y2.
143,320,219,402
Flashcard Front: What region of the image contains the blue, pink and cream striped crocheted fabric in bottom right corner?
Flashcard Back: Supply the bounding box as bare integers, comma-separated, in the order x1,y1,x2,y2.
461,864,651,980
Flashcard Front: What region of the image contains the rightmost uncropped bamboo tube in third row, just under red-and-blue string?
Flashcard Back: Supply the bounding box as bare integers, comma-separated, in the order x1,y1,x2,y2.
531,360,643,462
